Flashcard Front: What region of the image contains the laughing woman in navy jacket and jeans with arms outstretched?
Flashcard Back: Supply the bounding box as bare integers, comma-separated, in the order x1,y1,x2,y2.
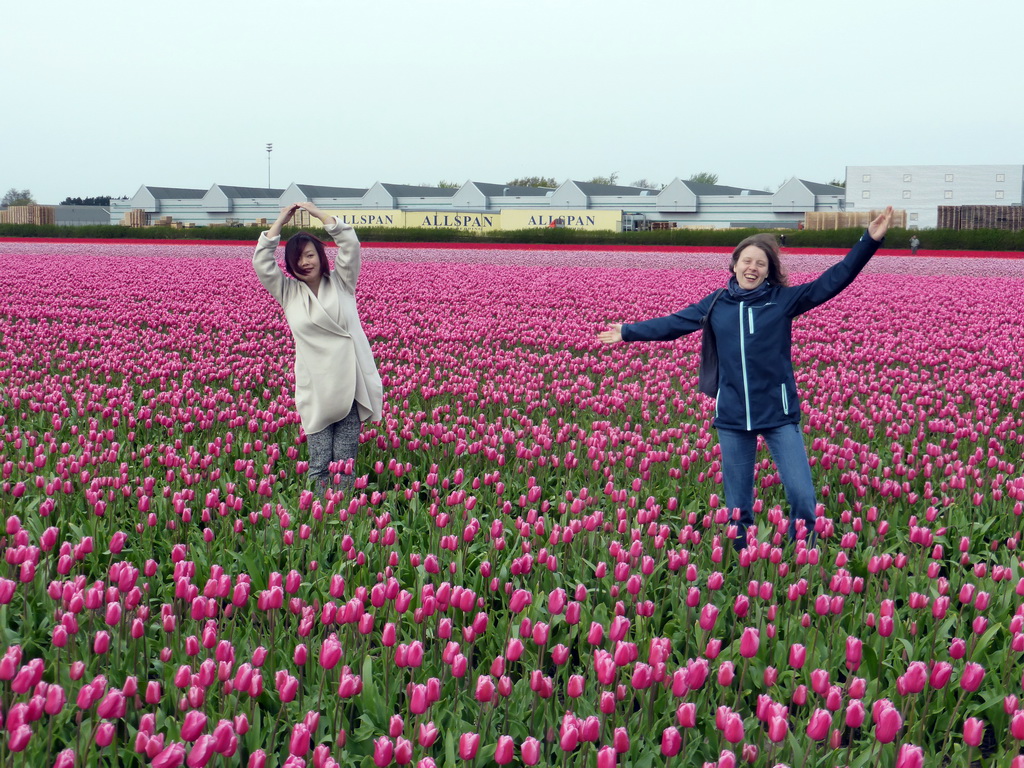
598,207,893,549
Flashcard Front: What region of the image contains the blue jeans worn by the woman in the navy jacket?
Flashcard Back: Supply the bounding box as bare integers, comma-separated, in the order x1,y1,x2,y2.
718,424,817,549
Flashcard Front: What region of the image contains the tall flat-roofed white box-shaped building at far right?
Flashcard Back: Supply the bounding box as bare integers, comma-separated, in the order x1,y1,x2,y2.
846,165,1024,229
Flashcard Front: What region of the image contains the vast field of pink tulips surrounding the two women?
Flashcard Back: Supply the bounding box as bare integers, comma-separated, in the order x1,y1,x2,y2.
0,242,1024,768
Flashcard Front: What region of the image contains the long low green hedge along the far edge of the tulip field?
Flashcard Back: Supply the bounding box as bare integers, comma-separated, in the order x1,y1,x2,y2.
0,224,1024,251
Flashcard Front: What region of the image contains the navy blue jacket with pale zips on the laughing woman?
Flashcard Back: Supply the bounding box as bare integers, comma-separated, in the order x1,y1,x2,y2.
623,231,882,431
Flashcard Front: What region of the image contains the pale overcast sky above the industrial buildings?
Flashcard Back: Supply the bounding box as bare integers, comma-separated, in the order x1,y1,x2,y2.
0,0,1024,203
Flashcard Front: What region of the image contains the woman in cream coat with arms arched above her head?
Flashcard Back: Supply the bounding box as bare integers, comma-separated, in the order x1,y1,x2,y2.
253,203,383,495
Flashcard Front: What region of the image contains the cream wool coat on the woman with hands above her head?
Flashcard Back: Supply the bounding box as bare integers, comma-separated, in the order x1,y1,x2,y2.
253,218,383,434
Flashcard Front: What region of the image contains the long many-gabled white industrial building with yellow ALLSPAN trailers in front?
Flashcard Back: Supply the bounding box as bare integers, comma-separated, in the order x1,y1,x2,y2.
111,178,845,229
